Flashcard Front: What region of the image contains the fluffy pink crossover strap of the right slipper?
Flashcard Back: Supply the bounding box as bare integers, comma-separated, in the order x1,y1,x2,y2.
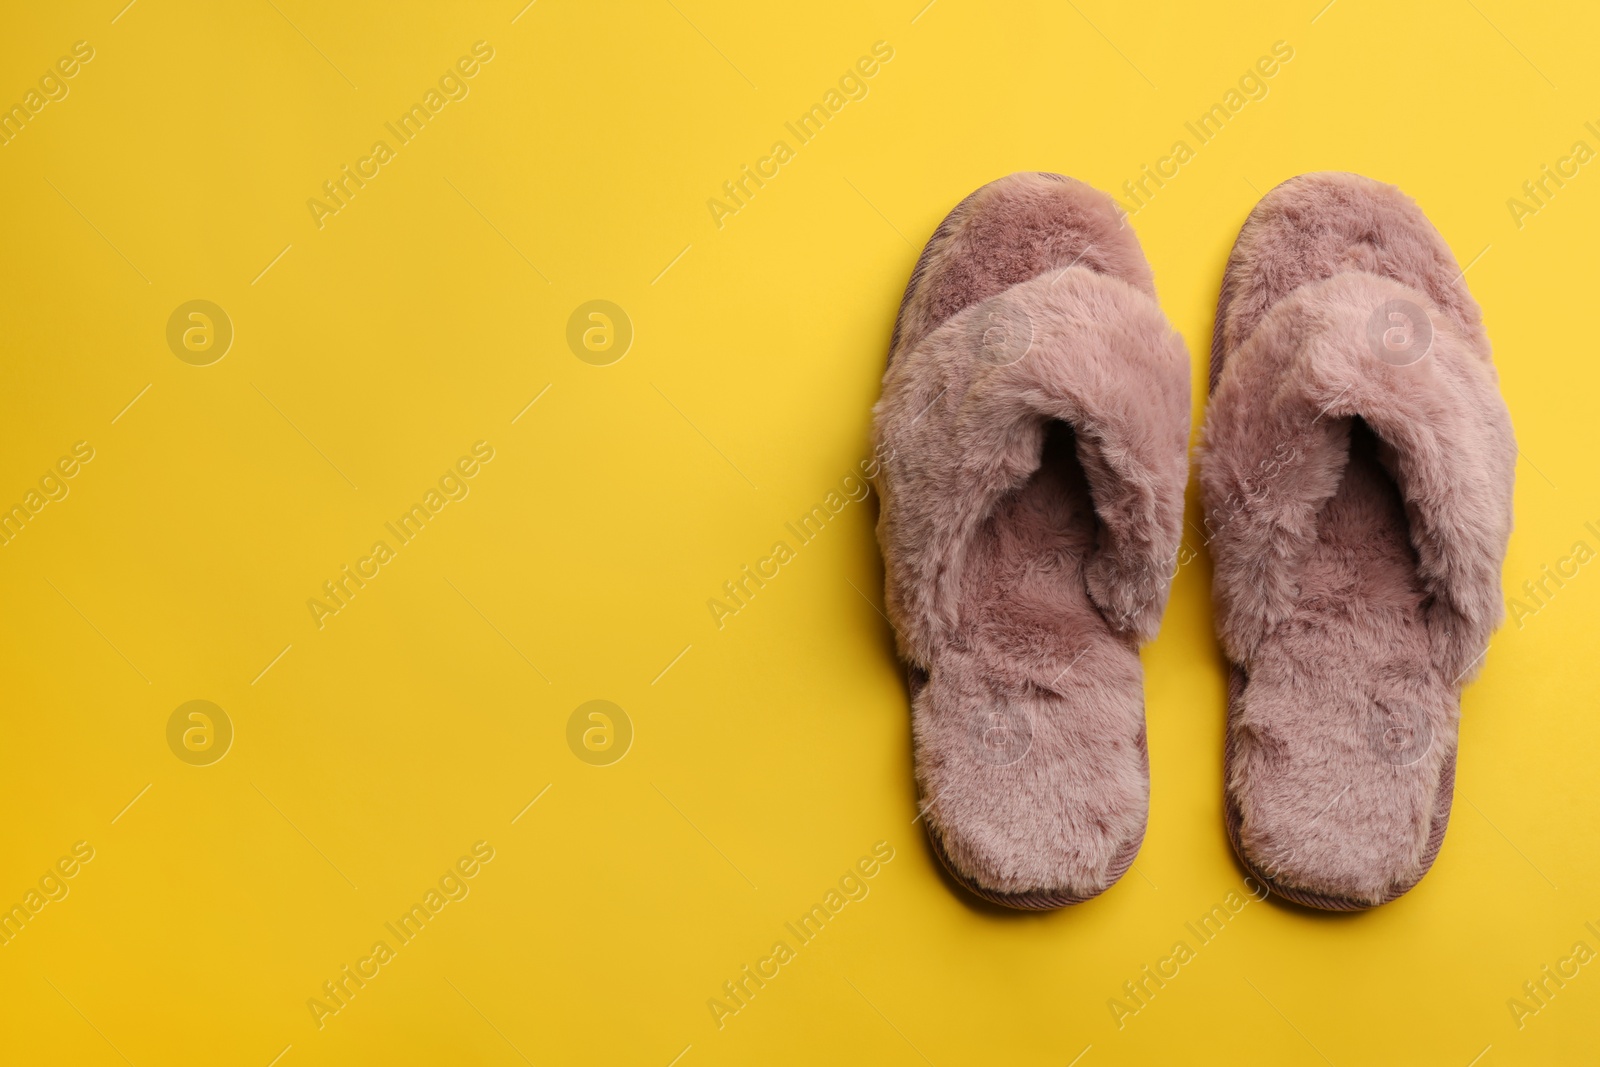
1200,272,1517,683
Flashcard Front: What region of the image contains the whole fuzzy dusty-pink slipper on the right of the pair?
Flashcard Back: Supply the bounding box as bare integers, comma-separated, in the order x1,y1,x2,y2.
1200,173,1517,910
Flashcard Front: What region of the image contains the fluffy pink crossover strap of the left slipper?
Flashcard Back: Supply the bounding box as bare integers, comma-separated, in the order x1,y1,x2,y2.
874,267,1189,665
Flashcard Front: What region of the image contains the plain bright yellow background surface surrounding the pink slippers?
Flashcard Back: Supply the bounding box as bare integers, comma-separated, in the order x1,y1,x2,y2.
0,0,1600,1067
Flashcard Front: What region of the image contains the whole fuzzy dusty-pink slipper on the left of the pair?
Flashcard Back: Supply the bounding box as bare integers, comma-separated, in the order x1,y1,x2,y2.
874,174,1189,909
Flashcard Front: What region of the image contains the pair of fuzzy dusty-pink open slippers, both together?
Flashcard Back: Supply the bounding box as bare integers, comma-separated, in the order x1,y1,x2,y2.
874,173,1515,910
